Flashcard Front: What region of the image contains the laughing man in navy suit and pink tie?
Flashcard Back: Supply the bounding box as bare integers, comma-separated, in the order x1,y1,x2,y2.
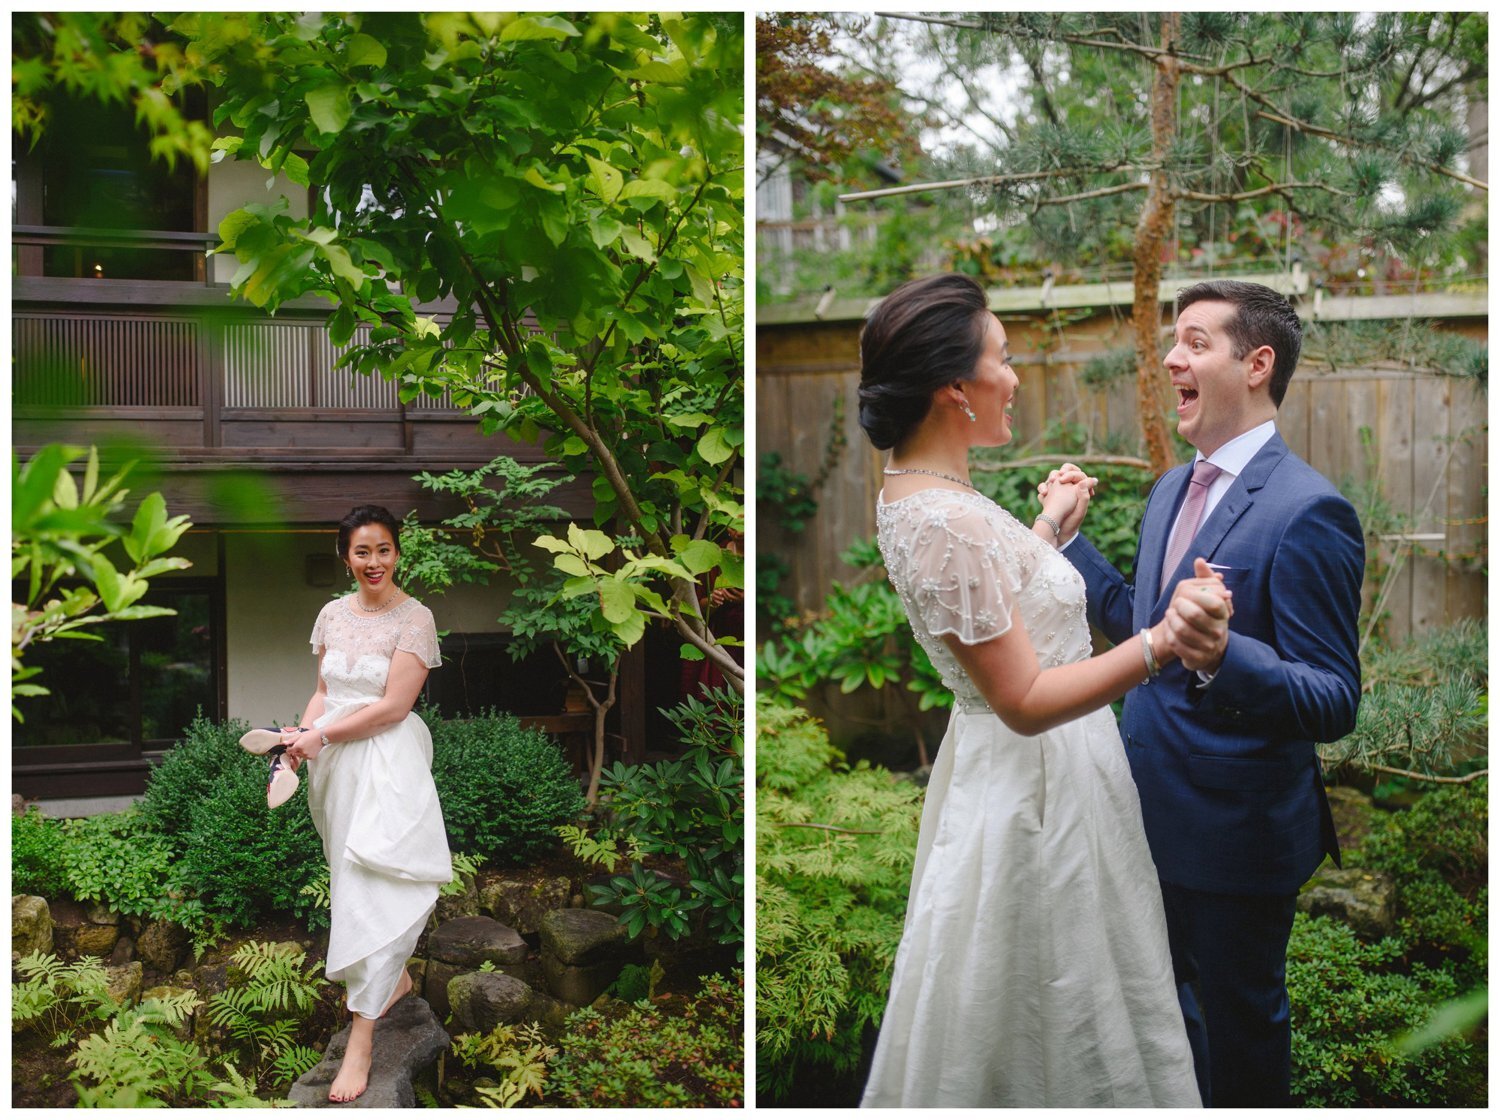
1064,280,1365,1107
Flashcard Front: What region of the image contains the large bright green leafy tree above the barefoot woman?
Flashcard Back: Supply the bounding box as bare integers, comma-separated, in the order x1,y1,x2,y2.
180,12,744,687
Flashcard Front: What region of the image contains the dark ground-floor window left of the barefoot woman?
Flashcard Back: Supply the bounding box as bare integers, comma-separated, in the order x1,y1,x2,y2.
12,580,224,752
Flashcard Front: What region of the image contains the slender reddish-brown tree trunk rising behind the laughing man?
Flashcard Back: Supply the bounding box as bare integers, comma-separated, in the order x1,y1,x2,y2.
1131,12,1181,477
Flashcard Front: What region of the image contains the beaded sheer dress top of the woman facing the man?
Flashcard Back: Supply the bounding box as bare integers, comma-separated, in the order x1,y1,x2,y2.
875,487,1091,712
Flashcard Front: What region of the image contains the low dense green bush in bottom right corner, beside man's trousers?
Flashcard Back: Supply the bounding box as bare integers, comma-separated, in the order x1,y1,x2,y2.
1287,915,1487,1108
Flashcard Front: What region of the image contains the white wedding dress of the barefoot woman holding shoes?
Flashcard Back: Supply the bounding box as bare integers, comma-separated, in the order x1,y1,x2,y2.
308,597,453,1018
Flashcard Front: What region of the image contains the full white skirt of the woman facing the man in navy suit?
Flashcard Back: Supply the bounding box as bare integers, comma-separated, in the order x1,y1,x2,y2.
863,709,1202,1108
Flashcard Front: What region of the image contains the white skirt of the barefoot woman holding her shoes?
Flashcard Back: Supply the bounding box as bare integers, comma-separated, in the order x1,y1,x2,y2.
308,700,453,1018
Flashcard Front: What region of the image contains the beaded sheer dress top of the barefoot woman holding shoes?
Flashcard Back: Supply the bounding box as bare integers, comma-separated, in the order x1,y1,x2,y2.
311,598,441,700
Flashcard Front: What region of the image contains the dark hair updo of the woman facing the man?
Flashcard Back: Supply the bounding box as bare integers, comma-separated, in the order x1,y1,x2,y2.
860,273,990,451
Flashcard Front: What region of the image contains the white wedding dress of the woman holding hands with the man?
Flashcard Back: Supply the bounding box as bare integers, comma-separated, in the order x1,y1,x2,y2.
863,489,1202,1107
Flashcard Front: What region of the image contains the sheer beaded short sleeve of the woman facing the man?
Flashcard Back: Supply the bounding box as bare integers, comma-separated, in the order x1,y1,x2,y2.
908,501,1020,646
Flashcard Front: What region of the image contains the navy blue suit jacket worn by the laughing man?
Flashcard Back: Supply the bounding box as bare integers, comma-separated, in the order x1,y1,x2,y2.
1064,435,1365,894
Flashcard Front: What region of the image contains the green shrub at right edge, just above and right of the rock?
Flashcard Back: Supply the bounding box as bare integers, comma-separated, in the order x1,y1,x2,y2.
1358,778,1490,985
